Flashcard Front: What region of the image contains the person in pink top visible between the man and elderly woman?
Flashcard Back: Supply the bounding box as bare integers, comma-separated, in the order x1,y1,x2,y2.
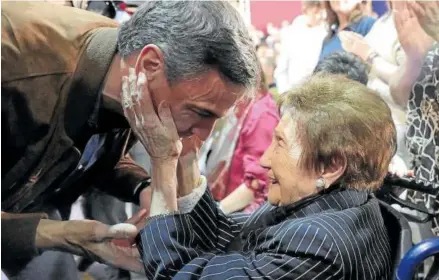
205,71,279,213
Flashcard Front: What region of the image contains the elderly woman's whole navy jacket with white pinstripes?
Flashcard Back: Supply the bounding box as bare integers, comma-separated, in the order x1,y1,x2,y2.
138,186,392,280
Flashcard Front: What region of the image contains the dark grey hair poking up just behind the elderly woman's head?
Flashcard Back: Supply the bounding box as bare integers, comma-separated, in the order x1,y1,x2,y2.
314,52,369,85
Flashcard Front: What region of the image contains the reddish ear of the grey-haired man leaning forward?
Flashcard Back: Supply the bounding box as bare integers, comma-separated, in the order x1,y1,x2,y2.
135,44,165,80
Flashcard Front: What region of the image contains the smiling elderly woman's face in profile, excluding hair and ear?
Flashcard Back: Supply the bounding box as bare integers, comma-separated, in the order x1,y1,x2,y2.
261,114,318,205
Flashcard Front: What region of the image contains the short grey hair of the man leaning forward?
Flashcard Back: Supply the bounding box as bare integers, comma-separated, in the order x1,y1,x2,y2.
118,1,259,94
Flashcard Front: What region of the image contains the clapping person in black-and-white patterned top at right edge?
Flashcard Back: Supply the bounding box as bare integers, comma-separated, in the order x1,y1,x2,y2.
390,1,439,236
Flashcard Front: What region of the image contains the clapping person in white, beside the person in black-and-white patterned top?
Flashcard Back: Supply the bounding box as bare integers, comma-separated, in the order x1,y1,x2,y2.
339,1,409,176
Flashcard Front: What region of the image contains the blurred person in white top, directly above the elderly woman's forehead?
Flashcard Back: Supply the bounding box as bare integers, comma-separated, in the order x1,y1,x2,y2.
274,1,327,94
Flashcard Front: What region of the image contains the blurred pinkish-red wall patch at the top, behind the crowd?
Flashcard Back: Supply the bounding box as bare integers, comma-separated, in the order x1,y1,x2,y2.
250,0,302,32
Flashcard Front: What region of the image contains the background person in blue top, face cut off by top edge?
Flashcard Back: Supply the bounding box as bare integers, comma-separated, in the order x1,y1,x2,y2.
320,0,375,60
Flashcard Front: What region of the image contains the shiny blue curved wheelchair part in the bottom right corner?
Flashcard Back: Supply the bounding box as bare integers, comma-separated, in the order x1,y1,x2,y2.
396,237,439,280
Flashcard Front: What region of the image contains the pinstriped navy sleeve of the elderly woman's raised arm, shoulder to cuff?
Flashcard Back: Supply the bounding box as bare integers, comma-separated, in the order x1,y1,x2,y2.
138,189,343,279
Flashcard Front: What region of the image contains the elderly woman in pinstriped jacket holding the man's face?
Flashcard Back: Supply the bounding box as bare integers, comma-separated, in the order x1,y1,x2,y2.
131,75,396,280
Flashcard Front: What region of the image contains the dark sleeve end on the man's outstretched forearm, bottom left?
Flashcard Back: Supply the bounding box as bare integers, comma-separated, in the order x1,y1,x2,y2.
1,212,47,277
